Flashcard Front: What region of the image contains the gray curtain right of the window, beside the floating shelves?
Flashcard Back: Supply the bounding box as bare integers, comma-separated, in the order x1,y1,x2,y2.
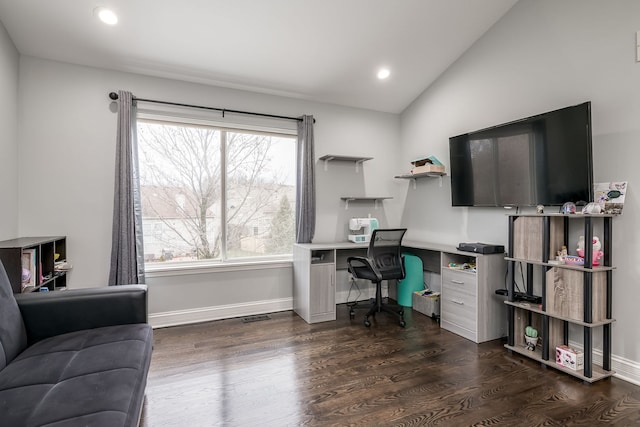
296,116,316,243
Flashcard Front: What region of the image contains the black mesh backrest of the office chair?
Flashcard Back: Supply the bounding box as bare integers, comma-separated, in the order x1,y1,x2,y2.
367,228,407,280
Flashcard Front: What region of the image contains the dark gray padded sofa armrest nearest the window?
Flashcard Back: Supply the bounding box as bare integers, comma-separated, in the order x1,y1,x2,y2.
16,285,148,345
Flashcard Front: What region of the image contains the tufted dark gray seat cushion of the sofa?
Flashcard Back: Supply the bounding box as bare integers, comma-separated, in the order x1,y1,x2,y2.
0,324,153,427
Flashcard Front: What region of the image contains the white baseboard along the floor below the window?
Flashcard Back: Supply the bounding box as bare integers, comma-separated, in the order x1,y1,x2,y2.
149,298,293,328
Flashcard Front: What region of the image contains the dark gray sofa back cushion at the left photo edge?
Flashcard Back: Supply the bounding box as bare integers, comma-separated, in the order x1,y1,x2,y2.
0,261,27,369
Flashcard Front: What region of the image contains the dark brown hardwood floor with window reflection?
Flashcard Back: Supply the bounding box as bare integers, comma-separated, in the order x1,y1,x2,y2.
141,305,640,427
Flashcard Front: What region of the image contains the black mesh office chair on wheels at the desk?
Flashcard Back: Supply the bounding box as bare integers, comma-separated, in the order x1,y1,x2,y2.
347,228,407,328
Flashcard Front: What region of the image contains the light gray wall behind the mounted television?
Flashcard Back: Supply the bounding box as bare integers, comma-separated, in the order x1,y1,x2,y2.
401,0,640,374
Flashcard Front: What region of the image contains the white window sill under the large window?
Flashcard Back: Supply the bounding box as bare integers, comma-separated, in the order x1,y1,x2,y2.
145,258,293,278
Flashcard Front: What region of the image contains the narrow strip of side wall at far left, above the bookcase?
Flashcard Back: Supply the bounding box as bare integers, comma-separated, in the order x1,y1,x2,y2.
0,23,19,240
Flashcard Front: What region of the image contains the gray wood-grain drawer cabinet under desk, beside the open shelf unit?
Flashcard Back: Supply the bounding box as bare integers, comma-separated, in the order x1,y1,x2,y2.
440,252,507,343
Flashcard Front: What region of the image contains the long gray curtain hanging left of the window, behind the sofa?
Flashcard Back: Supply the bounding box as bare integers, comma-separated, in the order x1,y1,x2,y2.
109,90,145,286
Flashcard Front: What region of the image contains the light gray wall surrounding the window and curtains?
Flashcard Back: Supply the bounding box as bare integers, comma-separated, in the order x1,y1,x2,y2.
19,57,400,319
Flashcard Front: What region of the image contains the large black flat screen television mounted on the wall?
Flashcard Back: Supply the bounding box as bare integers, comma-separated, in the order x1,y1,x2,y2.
449,102,593,207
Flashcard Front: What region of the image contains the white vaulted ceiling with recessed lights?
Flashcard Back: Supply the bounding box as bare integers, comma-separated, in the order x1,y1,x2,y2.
0,0,517,113
